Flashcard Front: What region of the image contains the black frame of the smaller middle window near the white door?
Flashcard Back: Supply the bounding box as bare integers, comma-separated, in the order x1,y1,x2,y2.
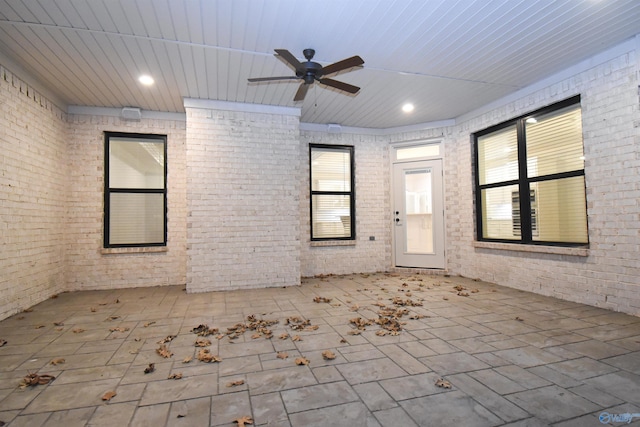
309,144,356,241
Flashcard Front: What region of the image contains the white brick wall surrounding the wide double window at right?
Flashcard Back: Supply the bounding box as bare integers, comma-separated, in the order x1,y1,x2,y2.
445,51,640,315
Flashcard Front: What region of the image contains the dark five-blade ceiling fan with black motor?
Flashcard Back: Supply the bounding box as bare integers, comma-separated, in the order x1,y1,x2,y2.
249,49,364,101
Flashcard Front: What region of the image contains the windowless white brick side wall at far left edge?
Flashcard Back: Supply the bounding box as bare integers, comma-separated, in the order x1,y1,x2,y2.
0,66,68,319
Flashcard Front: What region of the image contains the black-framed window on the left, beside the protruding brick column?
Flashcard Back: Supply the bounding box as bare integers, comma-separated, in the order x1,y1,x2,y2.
104,132,167,248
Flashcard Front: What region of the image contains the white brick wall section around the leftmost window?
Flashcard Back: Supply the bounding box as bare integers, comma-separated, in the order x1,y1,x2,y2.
65,114,187,290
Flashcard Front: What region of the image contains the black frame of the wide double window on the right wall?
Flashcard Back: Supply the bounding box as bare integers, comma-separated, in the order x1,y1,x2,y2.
471,95,589,247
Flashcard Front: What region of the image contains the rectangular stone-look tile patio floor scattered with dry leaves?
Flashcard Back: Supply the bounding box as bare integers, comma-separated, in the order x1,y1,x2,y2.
0,273,640,427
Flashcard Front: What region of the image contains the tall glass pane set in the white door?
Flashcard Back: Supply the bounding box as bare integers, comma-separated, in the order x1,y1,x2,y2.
404,168,433,254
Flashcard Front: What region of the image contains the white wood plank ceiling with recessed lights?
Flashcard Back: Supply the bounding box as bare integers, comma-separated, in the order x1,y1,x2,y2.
0,0,640,128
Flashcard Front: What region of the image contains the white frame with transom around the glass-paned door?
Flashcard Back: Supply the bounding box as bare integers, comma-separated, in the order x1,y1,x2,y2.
389,138,447,271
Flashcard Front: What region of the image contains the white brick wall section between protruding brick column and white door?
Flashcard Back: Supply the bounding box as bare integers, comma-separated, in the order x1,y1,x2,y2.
300,131,391,277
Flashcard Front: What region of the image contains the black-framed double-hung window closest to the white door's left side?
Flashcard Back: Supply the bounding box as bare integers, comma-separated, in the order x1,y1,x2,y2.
309,144,355,240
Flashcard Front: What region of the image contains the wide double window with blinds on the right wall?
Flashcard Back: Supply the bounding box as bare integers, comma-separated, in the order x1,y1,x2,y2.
473,96,588,246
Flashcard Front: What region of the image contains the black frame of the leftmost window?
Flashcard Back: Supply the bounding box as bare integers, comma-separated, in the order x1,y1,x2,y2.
103,131,168,248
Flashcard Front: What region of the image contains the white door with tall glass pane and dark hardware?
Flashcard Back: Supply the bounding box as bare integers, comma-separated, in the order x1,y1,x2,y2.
393,160,445,269
